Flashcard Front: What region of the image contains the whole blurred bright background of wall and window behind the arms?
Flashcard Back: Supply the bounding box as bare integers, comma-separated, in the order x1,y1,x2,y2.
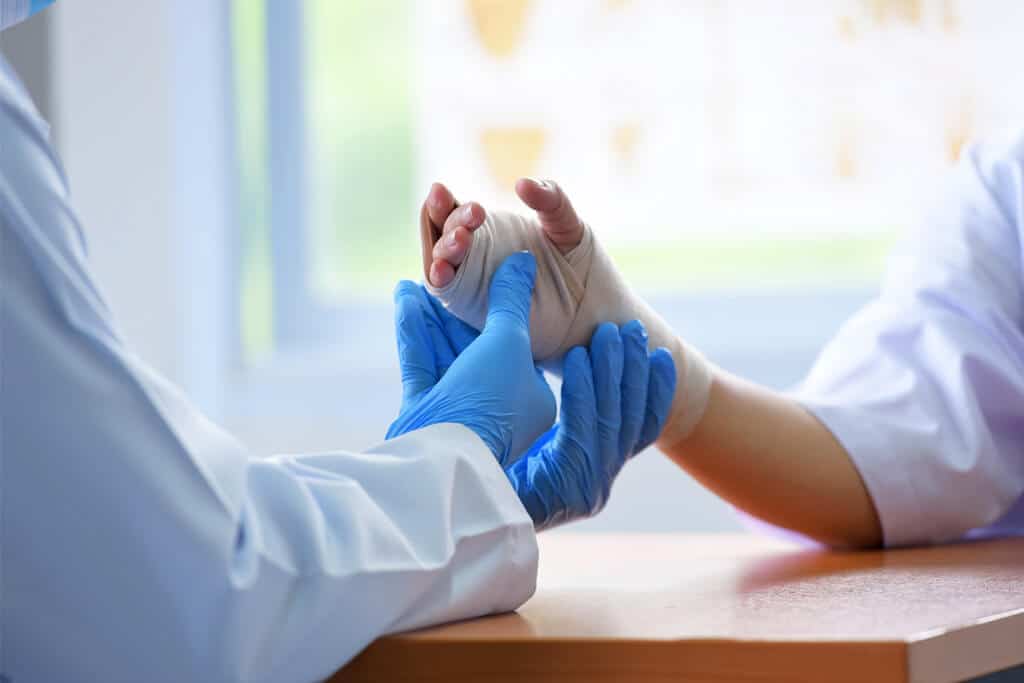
8,0,1024,530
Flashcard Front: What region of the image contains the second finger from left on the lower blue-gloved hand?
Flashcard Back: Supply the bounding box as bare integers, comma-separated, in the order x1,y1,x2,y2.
590,323,626,477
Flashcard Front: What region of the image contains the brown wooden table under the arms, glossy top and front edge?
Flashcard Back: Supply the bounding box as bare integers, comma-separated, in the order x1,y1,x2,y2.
332,533,1024,683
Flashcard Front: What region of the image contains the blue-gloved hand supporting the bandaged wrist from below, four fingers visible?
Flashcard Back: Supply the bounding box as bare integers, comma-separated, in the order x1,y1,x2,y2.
506,321,676,531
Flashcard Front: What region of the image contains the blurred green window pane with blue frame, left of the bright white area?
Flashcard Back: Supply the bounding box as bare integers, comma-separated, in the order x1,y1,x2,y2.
234,0,417,368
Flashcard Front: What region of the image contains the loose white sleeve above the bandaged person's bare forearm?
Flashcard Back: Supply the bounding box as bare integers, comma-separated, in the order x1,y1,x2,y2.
796,135,1024,546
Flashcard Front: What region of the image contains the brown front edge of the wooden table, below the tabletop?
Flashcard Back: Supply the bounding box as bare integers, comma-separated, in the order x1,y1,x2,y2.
330,636,910,683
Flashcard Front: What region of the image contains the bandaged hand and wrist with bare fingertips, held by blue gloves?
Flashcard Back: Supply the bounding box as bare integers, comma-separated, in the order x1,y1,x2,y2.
421,178,712,444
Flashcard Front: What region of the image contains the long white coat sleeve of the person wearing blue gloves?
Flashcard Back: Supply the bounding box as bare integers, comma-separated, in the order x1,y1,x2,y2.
0,62,537,681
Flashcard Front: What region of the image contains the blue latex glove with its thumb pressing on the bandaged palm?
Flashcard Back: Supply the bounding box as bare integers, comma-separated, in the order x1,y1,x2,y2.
387,252,555,467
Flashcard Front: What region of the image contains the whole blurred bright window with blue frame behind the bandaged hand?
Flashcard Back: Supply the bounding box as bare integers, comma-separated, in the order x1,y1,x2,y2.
233,0,1024,384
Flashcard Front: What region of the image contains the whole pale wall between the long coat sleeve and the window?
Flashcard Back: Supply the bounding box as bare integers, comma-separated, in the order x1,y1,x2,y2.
48,0,230,410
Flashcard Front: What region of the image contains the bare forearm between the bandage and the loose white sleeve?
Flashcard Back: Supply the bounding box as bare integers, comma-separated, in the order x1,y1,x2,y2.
658,371,882,547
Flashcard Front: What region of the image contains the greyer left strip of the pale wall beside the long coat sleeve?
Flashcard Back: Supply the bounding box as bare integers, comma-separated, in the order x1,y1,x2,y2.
49,0,182,381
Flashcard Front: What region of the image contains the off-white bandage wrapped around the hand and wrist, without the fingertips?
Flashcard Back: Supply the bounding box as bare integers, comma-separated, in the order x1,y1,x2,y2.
420,206,712,444
